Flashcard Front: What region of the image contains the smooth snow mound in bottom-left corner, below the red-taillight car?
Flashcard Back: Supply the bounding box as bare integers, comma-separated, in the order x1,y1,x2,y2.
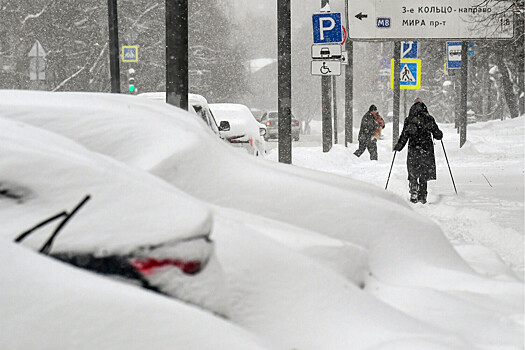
0,237,265,350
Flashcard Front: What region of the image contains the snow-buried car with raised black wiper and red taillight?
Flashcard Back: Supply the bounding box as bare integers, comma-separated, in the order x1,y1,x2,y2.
0,118,228,314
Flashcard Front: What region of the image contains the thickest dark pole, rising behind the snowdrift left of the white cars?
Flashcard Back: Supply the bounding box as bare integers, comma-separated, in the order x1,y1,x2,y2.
166,0,188,110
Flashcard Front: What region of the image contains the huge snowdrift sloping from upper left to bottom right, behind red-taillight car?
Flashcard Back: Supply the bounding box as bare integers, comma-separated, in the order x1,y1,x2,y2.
0,91,523,350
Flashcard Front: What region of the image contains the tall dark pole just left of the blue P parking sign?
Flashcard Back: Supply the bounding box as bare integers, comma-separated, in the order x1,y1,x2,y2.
277,0,292,164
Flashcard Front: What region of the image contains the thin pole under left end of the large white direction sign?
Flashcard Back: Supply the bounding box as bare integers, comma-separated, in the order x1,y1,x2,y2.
345,0,354,147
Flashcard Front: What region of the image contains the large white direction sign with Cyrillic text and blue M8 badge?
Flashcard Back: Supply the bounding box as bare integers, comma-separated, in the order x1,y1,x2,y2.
348,0,514,40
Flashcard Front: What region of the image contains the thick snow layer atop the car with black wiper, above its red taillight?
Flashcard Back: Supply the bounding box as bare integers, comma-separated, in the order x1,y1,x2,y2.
0,118,212,254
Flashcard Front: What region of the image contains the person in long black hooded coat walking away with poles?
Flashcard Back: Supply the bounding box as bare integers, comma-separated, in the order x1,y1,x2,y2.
394,97,443,204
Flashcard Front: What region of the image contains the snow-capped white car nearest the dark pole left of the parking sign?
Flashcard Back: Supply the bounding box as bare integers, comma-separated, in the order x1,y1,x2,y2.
210,103,266,156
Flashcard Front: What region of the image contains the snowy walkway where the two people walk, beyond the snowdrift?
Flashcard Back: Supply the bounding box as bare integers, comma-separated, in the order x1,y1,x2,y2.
268,117,524,280
